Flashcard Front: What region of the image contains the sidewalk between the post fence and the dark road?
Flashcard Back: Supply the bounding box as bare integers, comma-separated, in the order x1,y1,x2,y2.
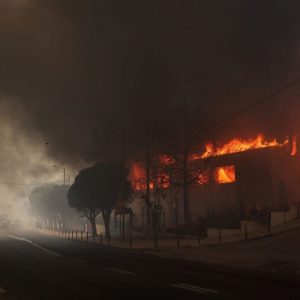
38,220,300,275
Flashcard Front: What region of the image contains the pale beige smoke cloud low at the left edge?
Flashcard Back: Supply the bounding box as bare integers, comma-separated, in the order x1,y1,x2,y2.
0,95,72,221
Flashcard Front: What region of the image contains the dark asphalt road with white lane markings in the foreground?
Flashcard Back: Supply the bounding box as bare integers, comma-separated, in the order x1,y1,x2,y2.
0,231,300,300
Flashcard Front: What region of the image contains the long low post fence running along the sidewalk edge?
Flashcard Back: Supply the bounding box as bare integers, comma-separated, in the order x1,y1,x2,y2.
40,219,300,249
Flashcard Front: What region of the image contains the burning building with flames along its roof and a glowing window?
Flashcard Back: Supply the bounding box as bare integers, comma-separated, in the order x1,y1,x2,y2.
131,135,300,227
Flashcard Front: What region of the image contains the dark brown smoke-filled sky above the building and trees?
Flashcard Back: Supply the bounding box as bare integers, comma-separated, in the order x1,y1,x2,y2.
0,0,300,216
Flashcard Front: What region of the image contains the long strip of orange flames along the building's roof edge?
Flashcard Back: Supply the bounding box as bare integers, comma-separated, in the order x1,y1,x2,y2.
198,135,289,158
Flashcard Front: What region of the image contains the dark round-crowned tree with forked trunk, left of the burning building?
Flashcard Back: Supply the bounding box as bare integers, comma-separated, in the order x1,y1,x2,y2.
68,162,132,238
